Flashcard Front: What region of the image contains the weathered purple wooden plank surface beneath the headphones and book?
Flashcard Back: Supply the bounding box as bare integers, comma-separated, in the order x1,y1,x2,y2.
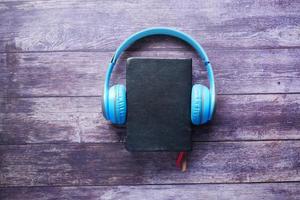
0,0,300,200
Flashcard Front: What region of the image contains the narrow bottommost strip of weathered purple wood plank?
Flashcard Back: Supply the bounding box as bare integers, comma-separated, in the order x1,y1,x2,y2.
0,183,300,200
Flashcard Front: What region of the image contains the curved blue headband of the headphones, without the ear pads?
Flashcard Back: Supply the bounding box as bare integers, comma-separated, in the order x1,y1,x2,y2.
102,27,215,118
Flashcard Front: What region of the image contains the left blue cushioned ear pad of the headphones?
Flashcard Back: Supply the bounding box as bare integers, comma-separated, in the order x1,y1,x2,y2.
108,85,127,125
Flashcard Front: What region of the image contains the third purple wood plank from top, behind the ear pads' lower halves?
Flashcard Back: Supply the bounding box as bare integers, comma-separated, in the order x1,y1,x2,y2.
0,94,300,144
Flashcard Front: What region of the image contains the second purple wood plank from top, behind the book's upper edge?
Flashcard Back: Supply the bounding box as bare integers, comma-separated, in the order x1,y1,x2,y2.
0,48,300,97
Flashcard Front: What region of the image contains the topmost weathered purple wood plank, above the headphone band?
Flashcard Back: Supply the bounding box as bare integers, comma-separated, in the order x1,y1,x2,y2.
0,0,300,52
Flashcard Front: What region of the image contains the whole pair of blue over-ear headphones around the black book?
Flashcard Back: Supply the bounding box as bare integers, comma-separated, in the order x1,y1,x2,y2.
102,27,216,125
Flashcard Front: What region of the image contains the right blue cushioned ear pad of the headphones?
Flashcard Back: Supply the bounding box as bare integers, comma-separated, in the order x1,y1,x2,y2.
191,84,210,125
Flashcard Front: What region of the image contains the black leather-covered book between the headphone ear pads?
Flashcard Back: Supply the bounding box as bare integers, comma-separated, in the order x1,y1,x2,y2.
126,58,192,151
